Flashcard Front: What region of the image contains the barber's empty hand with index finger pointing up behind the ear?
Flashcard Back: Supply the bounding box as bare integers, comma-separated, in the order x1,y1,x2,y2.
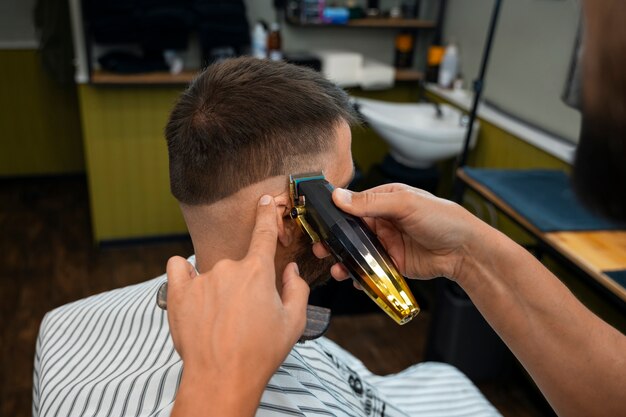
167,196,309,415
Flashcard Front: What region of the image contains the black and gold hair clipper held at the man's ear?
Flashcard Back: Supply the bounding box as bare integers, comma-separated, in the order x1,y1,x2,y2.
289,173,419,324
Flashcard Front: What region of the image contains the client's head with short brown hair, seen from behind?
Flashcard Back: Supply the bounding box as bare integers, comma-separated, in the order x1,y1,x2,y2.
165,58,356,283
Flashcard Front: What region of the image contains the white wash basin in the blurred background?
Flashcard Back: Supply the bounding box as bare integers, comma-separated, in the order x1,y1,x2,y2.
353,97,480,168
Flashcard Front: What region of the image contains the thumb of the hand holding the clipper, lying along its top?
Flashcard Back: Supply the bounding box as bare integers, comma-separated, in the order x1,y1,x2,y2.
333,188,398,218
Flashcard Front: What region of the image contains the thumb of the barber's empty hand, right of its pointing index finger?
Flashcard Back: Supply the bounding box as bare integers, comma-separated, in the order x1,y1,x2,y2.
281,262,310,342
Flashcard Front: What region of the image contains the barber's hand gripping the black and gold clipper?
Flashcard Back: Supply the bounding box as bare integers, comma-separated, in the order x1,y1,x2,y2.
313,184,484,280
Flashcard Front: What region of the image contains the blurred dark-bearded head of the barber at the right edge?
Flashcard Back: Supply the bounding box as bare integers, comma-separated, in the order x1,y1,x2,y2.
573,0,626,222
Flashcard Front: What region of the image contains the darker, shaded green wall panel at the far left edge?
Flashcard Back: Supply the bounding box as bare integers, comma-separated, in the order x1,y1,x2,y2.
0,50,84,177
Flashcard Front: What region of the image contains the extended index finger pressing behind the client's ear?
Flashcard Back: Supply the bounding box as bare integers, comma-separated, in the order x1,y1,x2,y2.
248,195,278,260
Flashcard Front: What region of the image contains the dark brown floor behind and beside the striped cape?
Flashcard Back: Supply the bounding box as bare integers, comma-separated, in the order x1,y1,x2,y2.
0,176,542,417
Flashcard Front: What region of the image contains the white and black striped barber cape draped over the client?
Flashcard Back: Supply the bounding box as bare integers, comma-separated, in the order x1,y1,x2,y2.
33,259,499,417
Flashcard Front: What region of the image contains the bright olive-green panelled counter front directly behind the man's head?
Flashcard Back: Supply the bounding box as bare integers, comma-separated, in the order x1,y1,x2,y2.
79,85,187,241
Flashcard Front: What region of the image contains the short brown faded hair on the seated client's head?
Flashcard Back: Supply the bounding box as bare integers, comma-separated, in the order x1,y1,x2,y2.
165,57,356,205
